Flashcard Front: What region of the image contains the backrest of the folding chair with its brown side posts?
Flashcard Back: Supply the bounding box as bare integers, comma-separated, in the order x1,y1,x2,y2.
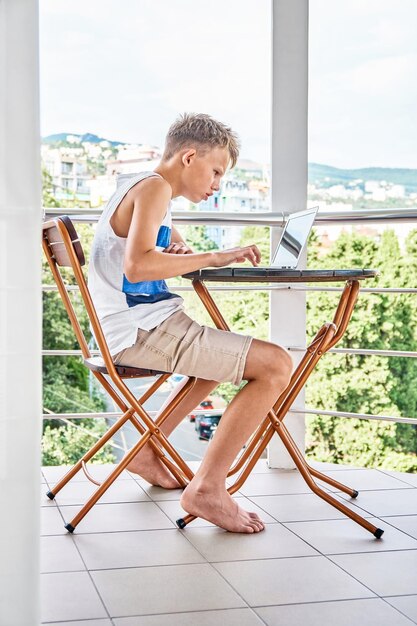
42,215,114,373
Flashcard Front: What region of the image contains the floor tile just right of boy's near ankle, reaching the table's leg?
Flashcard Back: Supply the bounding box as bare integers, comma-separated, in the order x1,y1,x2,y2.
240,470,318,496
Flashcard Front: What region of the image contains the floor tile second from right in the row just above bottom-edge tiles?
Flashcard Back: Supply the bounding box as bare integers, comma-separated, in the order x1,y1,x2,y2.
213,556,373,606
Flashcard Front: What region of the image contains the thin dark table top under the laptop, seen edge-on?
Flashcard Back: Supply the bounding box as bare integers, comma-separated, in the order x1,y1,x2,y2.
183,267,378,283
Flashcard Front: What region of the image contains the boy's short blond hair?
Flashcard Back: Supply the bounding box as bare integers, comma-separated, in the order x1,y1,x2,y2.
162,113,240,167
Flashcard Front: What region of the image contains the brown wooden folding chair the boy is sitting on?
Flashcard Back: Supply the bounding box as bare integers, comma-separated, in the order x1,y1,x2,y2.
42,216,195,533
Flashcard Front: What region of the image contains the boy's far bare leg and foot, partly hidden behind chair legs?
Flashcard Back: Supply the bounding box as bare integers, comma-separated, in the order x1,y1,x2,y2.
127,378,219,489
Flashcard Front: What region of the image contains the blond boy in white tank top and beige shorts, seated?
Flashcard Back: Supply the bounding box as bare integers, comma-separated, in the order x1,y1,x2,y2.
89,114,292,533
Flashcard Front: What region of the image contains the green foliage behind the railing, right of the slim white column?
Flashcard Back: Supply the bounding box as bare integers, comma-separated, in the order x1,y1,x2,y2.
306,225,417,471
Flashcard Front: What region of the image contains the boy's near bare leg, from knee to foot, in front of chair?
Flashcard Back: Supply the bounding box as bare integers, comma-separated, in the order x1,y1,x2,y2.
181,339,292,533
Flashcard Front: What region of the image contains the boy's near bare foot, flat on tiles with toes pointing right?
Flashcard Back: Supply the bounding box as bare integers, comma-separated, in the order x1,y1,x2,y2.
180,478,265,533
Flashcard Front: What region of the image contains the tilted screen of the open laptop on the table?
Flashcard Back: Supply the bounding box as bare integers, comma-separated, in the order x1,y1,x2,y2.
271,207,318,268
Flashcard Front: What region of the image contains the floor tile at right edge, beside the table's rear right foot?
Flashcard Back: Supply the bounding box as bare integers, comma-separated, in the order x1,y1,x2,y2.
339,489,417,517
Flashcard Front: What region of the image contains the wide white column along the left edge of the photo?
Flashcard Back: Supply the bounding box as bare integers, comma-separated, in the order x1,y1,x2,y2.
0,0,41,626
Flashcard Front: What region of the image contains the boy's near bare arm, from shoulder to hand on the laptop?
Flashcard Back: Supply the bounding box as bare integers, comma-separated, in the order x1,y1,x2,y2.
124,178,260,282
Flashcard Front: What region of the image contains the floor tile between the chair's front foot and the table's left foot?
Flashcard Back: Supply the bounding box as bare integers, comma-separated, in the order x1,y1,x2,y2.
61,502,174,533
